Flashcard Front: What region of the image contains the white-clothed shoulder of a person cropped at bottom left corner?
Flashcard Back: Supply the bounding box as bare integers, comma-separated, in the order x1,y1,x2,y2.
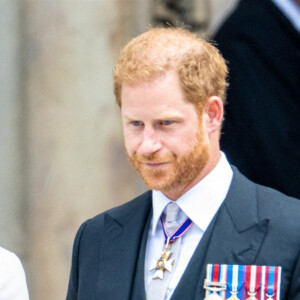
0,247,29,300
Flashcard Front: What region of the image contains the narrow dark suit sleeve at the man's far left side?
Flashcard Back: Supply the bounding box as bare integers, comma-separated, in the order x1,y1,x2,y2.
66,222,86,300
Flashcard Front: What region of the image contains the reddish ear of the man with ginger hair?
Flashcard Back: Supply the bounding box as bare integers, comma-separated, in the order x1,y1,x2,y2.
203,96,224,133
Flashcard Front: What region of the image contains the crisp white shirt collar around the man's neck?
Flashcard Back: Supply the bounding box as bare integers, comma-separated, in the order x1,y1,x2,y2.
151,152,233,234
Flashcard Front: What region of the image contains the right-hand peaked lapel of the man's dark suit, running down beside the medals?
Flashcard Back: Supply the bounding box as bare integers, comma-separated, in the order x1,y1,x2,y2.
172,168,269,300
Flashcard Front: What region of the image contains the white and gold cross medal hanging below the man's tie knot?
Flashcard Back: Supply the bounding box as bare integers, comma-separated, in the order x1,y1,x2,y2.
149,240,175,279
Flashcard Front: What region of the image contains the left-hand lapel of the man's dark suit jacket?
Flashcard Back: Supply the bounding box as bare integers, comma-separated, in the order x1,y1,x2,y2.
98,192,152,299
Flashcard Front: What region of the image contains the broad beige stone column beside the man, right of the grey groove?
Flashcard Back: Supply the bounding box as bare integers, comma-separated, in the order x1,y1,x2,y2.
23,0,145,300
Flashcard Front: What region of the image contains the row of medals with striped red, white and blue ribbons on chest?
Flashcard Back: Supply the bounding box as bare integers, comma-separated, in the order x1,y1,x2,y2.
204,264,281,300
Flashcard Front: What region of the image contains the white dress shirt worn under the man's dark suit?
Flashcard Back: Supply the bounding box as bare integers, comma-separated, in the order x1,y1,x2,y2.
145,153,233,300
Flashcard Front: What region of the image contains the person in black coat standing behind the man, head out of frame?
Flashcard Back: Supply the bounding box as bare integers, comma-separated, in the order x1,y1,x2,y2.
214,0,300,198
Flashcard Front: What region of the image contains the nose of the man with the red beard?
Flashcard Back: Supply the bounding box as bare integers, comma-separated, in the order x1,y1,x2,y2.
138,129,161,156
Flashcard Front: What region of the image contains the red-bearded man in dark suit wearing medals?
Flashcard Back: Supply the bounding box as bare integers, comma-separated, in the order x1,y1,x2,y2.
67,28,300,300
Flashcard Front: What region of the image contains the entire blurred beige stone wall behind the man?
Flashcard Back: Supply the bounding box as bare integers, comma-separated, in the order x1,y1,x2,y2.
0,0,237,300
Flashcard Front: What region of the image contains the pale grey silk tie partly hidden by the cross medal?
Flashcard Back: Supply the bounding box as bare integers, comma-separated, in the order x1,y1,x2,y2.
147,202,181,300
